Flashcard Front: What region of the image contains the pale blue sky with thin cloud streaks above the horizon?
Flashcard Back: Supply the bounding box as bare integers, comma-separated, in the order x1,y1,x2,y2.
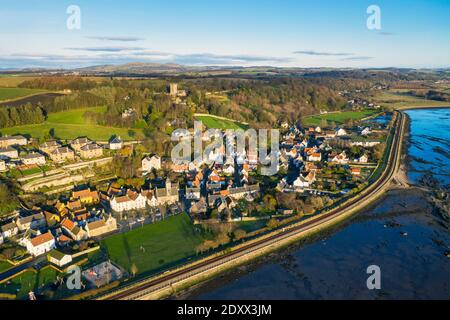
0,0,450,68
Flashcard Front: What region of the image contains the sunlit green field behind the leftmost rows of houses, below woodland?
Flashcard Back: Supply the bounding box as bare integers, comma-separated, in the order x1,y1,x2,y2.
0,107,142,141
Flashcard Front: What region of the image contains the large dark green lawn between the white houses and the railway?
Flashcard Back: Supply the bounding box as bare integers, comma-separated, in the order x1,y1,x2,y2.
102,214,204,274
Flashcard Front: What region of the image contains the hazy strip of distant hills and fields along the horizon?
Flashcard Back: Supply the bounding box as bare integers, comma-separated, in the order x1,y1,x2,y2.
1,62,450,81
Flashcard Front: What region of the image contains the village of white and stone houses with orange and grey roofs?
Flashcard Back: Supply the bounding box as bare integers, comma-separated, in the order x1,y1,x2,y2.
0,84,390,296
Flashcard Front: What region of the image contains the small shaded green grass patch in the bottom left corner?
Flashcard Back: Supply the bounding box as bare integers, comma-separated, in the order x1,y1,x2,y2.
0,267,58,299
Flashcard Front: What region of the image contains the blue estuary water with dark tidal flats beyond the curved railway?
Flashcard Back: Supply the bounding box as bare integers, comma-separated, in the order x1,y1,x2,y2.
184,109,450,300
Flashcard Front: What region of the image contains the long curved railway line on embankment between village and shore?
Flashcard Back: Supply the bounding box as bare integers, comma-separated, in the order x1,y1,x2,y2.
99,112,405,300
